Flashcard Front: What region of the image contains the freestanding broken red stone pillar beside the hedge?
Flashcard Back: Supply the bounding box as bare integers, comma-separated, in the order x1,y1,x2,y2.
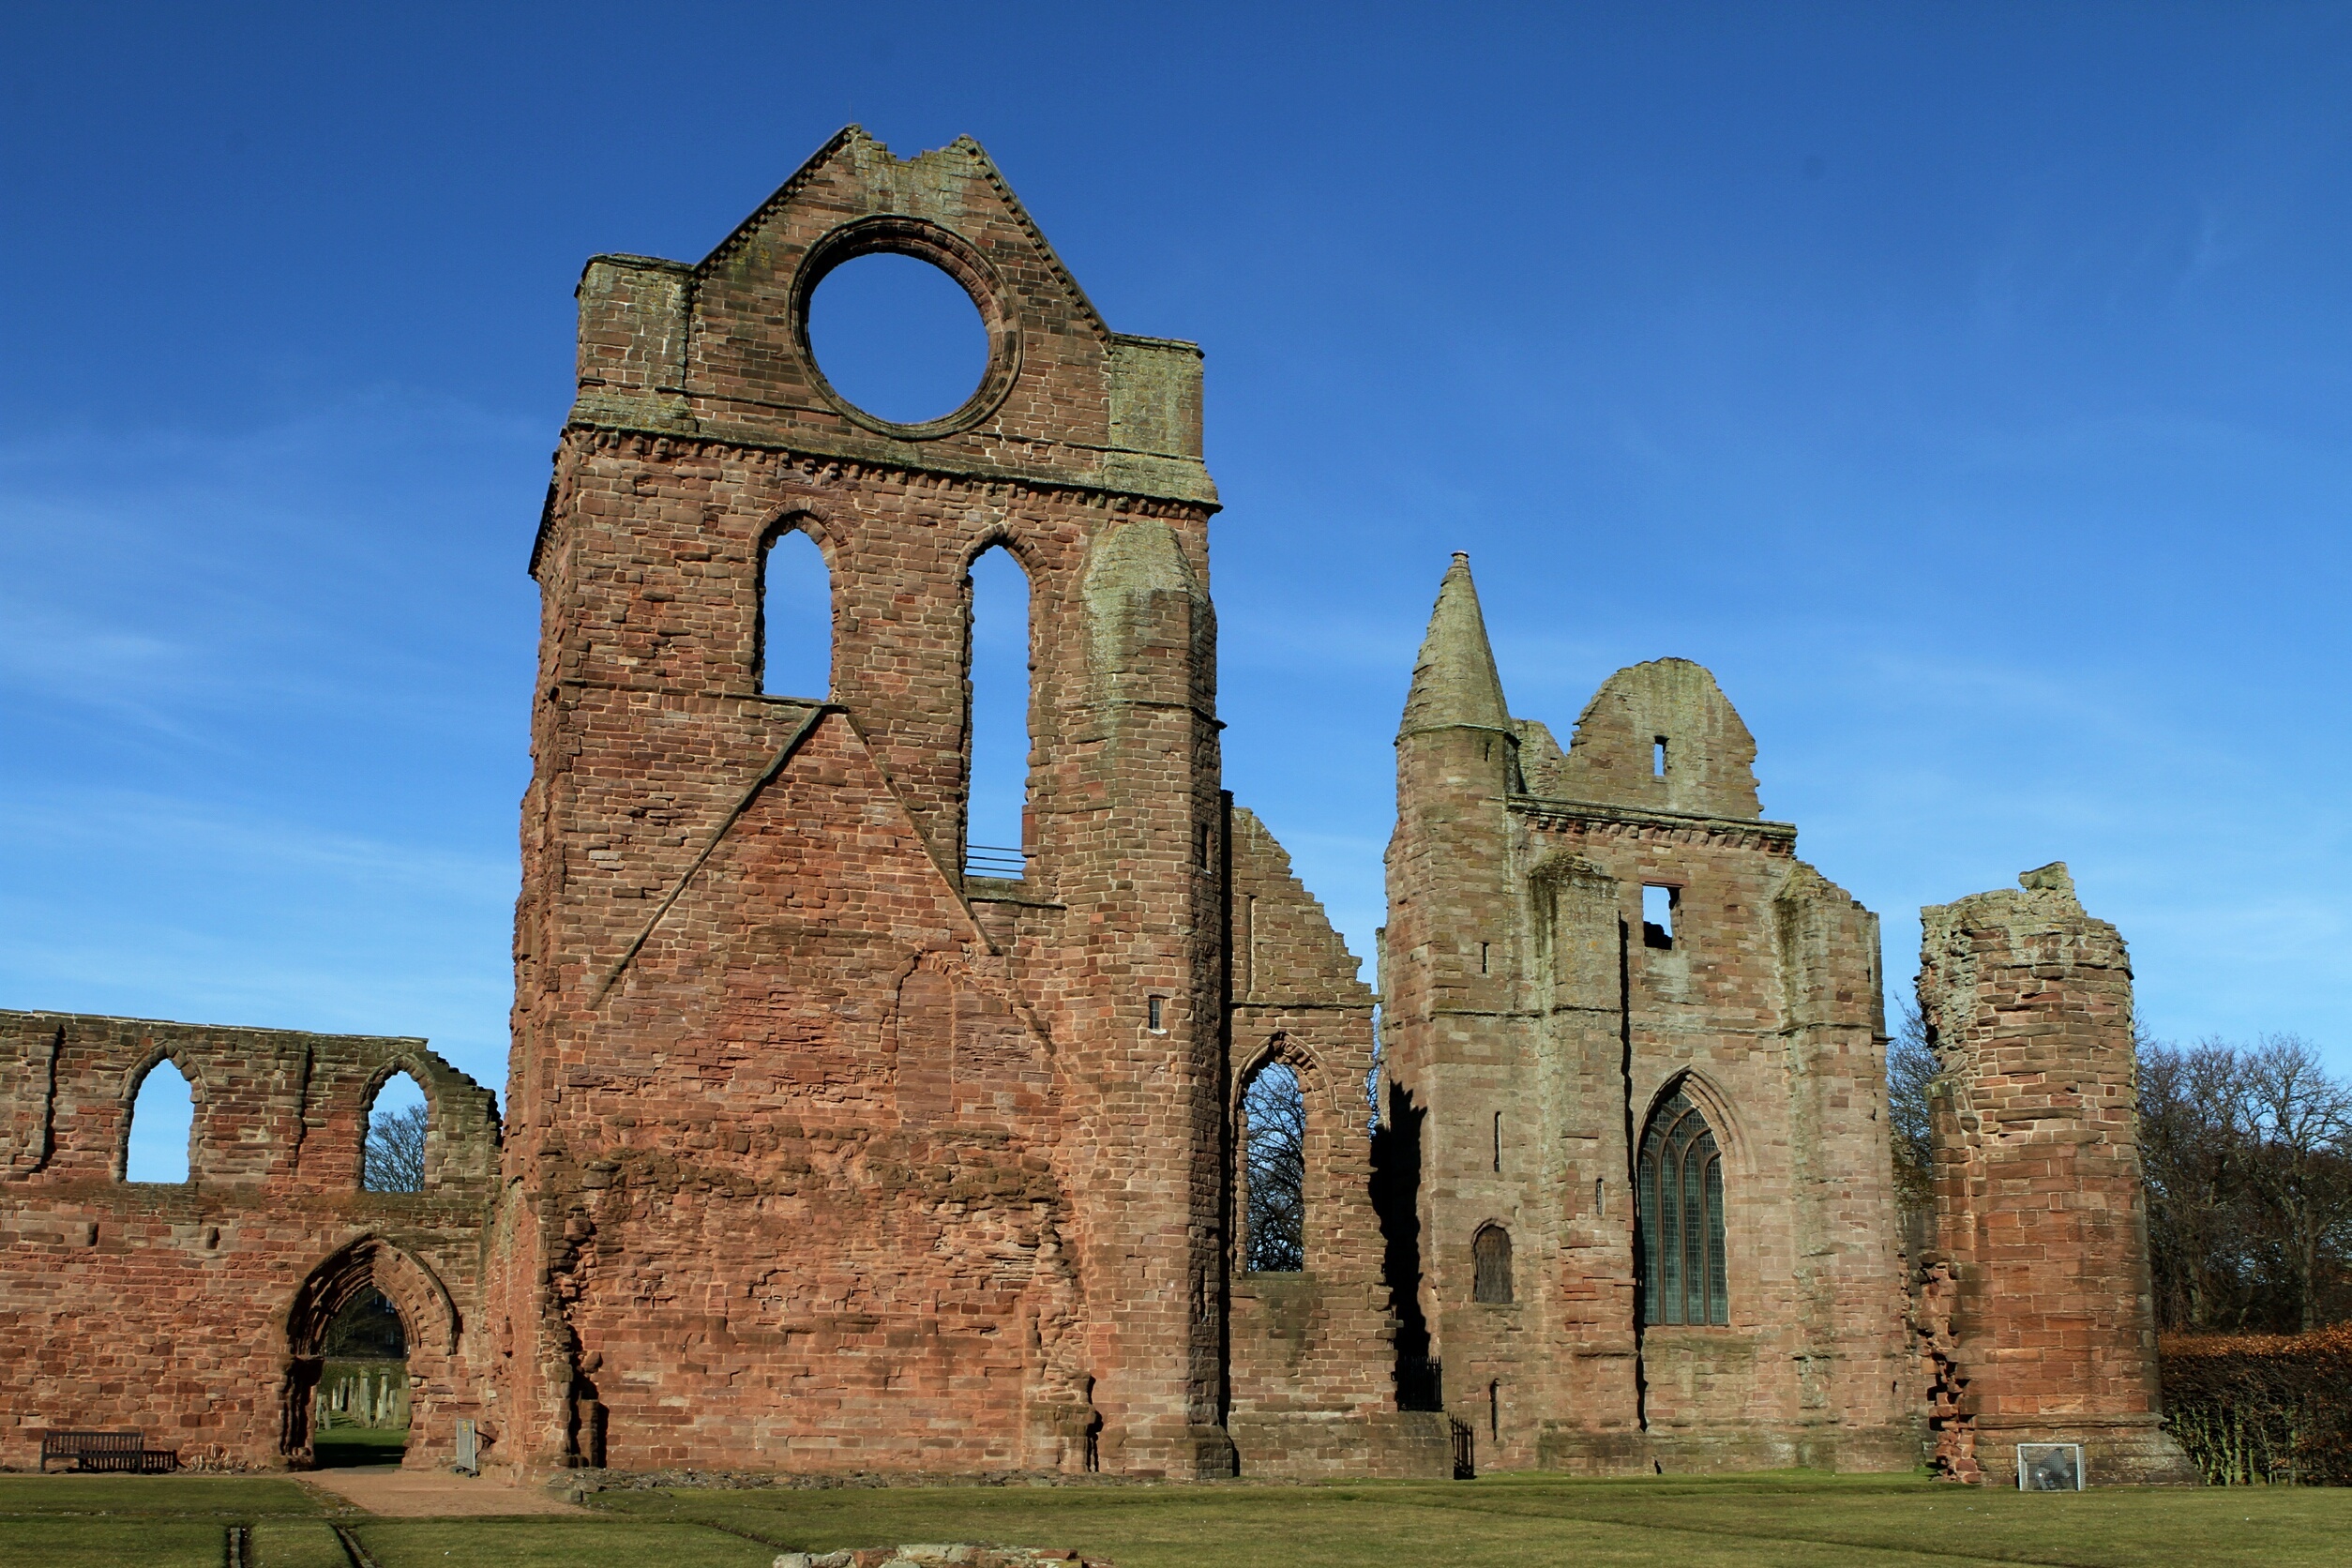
1920,865,2196,1484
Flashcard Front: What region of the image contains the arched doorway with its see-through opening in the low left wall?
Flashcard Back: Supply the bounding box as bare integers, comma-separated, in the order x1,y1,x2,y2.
279,1237,457,1470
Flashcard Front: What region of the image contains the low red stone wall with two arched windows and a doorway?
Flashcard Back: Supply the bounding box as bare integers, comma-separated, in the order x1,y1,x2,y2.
0,1011,499,1470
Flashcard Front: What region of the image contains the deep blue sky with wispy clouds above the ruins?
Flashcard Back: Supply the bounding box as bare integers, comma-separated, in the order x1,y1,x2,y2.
0,3,2352,1161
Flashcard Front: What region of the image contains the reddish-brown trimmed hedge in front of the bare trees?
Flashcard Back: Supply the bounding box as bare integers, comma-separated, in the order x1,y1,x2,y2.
2159,1323,2352,1485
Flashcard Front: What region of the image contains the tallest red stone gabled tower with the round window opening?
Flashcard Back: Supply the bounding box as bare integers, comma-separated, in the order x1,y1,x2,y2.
485,127,1232,1476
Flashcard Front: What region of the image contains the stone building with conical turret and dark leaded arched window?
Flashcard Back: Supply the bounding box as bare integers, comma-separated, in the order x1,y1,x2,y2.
1380,555,1917,1471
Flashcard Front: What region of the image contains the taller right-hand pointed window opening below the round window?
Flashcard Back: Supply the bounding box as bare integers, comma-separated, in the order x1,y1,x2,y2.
964,546,1031,877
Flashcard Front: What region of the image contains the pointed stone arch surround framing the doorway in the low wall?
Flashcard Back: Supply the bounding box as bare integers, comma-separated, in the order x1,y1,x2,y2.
278,1237,457,1470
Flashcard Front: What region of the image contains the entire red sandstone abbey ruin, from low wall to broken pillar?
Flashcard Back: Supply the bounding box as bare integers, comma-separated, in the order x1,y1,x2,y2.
0,129,2190,1484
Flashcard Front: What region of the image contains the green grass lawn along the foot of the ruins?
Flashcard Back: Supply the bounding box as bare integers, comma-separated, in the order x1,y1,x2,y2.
0,1471,2352,1568
